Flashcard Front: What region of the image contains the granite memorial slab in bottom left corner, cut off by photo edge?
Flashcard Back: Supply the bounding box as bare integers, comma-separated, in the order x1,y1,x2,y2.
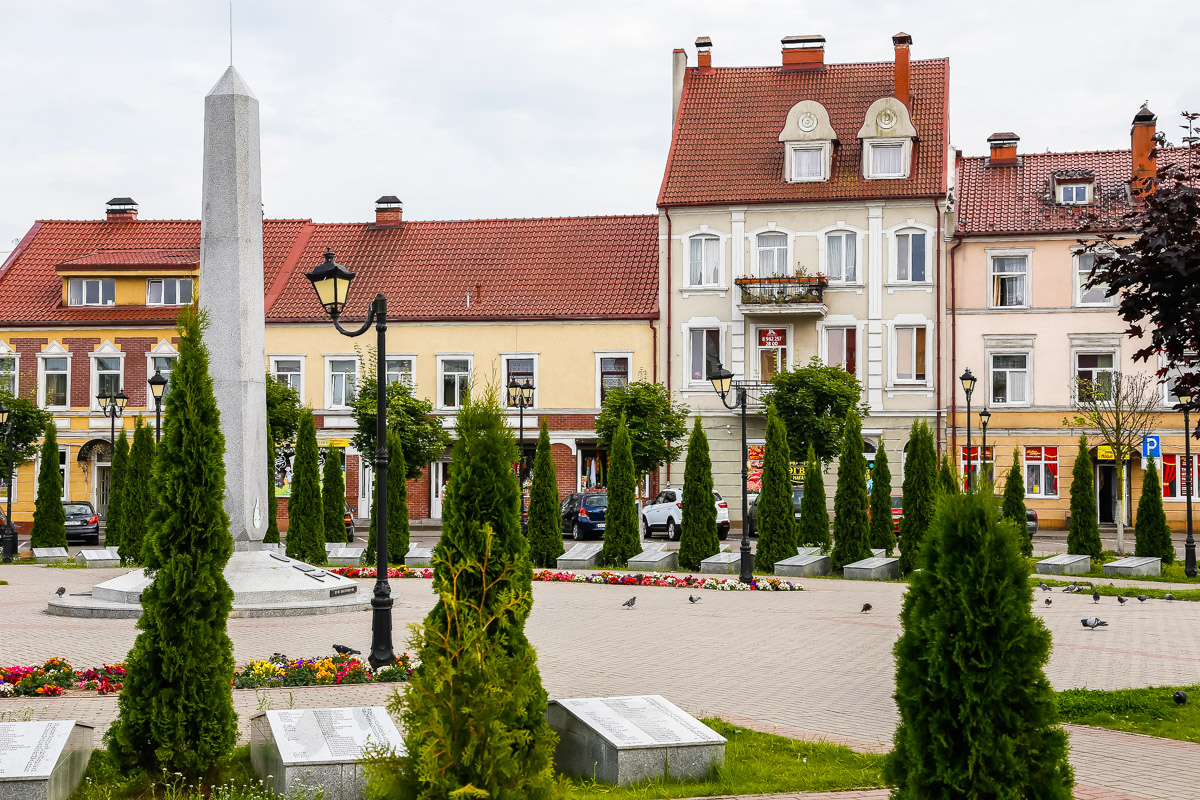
0,720,92,800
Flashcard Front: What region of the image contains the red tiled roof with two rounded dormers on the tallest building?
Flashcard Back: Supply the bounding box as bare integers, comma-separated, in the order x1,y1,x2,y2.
659,59,949,206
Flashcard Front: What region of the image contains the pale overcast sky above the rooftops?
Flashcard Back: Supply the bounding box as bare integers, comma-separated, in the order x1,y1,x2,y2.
0,0,1200,255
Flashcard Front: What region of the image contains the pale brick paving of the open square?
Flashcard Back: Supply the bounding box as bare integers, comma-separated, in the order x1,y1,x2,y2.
0,566,1200,800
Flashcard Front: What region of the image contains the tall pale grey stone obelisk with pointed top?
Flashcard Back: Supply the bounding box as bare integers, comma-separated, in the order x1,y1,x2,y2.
199,66,268,551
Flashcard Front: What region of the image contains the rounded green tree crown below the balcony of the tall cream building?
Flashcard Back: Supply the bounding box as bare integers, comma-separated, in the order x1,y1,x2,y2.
768,356,868,464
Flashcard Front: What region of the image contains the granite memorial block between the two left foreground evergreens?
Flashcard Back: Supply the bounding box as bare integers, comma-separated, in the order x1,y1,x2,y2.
250,705,404,800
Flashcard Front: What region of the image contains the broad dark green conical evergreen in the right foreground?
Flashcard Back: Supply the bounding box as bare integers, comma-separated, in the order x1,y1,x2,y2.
884,494,1073,800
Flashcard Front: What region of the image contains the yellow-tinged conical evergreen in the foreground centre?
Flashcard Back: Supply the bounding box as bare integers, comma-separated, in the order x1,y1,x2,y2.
370,389,556,800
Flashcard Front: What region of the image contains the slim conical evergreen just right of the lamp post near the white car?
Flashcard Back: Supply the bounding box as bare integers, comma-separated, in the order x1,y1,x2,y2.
754,405,797,572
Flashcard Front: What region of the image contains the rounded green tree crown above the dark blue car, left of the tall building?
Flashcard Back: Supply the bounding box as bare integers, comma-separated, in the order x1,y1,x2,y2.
596,380,688,489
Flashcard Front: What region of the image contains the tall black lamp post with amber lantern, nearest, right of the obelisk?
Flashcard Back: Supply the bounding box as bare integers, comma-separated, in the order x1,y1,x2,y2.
305,247,393,669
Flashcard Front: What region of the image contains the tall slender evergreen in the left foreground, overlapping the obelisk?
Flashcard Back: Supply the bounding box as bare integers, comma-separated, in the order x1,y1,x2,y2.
106,306,238,781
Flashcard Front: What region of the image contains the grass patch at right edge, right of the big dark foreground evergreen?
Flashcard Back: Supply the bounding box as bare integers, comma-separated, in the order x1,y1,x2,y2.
1057,684,1200,742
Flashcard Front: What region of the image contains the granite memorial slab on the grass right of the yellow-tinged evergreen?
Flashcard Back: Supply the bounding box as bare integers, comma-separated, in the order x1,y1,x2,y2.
546,694,725,786
